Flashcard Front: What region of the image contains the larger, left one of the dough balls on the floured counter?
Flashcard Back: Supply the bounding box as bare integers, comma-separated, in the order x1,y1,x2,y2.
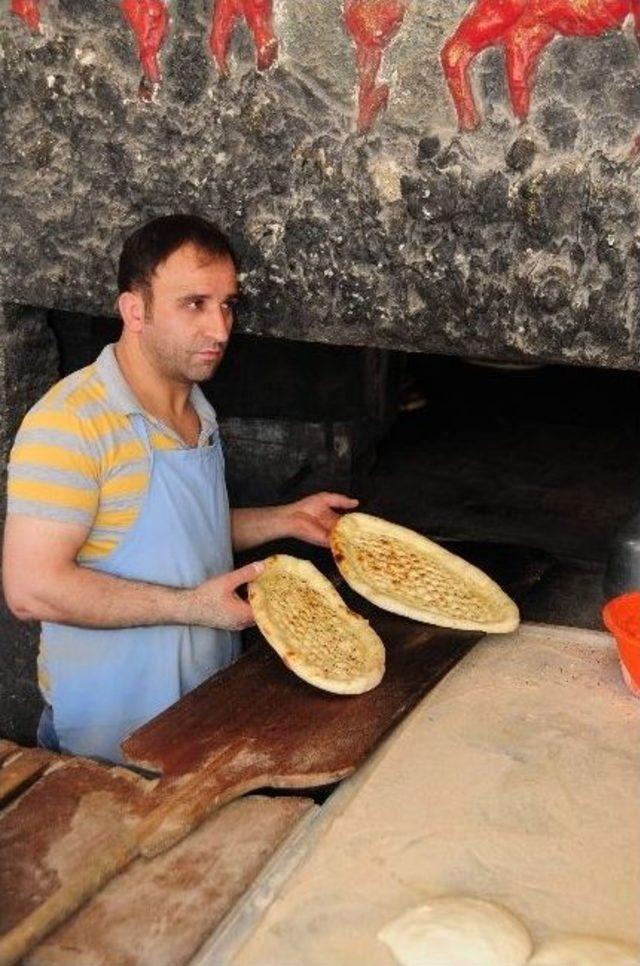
378,896,532,966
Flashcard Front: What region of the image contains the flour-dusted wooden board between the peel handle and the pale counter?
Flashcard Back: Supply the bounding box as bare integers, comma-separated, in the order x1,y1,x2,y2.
25,796,317,966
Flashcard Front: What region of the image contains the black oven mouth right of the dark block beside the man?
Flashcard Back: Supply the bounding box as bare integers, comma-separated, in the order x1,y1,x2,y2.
370,355,640,629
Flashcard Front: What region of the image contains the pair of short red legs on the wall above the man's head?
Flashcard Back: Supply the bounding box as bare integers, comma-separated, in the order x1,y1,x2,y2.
209,0,278,73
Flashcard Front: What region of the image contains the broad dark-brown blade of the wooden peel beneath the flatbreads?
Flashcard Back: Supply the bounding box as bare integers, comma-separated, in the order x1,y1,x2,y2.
122,545,547,855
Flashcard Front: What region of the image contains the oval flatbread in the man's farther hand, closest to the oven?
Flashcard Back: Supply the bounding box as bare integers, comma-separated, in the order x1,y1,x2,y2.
331,513,520,634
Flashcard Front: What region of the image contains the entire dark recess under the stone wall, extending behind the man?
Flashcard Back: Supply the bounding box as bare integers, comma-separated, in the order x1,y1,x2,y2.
49,304,640,628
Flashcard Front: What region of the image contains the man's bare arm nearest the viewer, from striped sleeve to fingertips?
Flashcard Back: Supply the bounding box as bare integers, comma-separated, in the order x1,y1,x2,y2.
2,515,263,630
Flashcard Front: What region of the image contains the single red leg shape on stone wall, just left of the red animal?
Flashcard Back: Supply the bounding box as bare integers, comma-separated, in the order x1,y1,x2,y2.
344,0,409,132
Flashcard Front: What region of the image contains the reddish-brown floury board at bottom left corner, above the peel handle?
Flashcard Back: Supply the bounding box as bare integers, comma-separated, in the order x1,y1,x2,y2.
0,756,155,964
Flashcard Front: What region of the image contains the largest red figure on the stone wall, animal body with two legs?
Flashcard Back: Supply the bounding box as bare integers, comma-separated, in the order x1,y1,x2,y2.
441,0,640,131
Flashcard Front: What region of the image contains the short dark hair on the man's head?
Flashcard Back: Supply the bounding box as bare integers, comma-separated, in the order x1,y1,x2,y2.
118,215,238,293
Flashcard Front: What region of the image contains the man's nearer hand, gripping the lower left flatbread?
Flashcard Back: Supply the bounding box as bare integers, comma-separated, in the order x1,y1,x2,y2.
189,561,264,631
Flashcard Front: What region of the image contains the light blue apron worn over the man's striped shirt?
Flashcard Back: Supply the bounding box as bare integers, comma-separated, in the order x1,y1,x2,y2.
41,414,240,762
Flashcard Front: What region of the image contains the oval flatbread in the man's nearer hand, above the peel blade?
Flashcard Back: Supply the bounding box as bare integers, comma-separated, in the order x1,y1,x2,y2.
249,554,385,694
